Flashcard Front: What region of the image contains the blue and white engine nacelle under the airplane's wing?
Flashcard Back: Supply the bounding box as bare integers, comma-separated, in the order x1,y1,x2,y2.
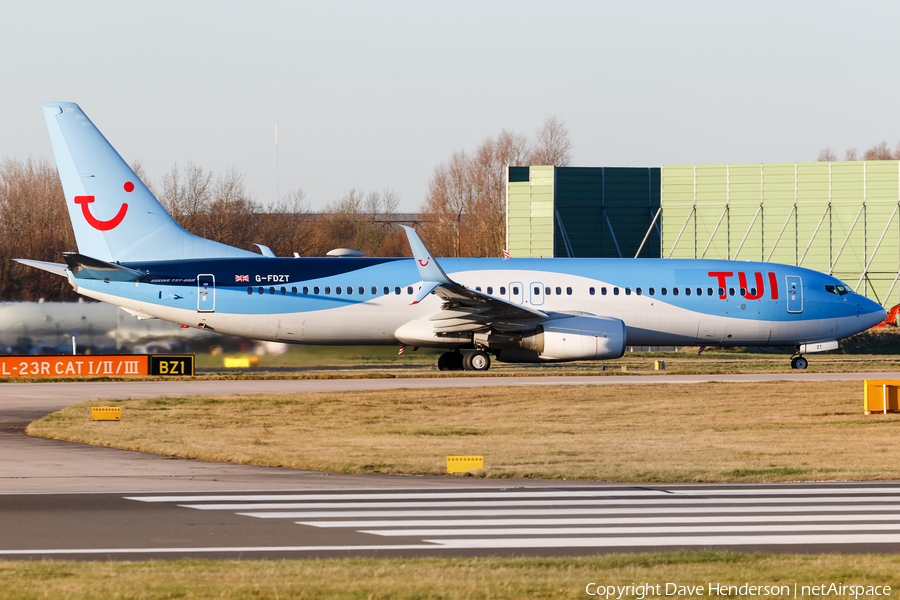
522,317,625,361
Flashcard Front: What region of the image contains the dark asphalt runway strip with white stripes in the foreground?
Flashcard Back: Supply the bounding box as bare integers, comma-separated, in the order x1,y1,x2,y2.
0,482,900,560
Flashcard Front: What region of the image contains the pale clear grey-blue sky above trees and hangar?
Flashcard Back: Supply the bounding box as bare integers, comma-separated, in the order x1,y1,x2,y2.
0,0,900,212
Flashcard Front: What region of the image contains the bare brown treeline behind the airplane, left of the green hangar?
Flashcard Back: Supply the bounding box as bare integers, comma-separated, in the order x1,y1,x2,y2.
0,117,572,301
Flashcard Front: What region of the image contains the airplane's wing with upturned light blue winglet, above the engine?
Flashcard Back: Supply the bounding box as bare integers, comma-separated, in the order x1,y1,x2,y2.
403,225,549,333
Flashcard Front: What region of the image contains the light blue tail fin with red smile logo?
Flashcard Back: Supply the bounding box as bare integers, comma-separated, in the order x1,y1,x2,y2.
43,102,258,262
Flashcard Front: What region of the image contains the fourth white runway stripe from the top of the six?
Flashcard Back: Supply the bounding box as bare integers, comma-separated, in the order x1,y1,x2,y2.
297,513,900,529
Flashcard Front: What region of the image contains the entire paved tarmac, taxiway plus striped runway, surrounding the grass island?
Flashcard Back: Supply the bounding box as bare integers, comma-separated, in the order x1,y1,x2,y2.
0,373,900,560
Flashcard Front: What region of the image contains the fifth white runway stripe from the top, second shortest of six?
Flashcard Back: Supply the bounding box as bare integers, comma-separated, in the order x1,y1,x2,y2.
359,523,900,537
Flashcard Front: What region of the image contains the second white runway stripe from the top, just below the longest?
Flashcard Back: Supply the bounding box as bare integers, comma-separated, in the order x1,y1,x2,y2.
178,496,900,511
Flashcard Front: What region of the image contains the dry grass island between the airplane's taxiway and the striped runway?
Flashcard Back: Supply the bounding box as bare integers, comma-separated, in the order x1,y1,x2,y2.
28,382,900,482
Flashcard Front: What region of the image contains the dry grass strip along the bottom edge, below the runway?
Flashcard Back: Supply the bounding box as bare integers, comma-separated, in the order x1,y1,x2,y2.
0,551,900,600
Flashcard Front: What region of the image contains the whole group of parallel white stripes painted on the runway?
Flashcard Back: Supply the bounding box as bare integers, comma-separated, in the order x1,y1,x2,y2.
121,485,900,553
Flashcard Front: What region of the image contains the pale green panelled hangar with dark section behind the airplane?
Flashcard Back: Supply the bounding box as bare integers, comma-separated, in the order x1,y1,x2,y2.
506,160,900,307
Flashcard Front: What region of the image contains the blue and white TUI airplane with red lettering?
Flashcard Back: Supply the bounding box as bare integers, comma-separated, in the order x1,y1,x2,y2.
17,102,886,372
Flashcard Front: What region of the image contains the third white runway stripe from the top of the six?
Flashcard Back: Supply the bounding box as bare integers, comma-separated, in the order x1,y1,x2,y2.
237,504,900,519
